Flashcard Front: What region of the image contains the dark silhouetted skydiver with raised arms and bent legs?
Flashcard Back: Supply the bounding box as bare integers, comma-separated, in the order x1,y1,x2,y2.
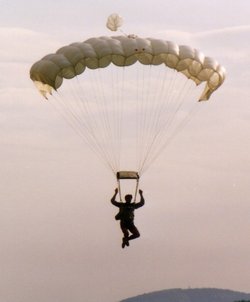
111,188,145,248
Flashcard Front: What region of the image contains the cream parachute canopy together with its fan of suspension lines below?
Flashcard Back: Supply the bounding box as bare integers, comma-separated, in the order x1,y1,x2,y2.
30,35,225,175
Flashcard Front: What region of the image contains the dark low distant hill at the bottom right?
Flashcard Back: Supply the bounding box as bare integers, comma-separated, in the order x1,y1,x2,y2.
120,288,250,302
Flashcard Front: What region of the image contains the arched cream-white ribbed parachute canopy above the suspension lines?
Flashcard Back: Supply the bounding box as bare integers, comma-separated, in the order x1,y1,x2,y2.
30,36,225,101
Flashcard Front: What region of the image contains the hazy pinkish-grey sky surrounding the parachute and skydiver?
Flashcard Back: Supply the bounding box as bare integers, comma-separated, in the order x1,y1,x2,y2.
0,0,250,302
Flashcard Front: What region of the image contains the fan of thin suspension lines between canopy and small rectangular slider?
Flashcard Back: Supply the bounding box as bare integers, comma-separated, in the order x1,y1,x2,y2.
46,63,204,178
